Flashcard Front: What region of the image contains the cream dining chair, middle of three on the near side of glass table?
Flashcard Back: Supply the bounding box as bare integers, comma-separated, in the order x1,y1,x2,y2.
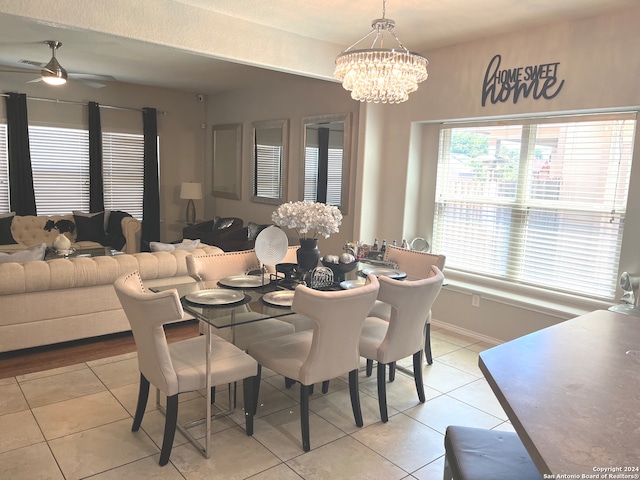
248,275,379,452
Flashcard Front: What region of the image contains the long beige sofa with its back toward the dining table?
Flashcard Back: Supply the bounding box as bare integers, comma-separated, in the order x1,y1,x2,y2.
0,245,222,352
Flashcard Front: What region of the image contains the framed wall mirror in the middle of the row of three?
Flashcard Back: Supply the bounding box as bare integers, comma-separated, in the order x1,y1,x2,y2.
251,120,289,205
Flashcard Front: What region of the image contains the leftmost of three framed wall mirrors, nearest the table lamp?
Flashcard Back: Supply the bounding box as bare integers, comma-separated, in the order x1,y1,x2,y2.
212,123,242,200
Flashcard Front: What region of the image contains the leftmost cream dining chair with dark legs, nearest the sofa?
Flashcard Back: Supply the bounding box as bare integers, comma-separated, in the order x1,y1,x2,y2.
114,271,258,465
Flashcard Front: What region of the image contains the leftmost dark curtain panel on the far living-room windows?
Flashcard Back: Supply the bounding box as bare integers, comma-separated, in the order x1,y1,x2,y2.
5,93,36,215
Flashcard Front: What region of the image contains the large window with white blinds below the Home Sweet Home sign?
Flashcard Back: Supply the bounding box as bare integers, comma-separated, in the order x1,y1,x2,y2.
433,113,636,300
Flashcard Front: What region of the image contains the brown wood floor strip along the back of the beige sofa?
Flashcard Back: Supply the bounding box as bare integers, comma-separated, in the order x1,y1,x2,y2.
0,320,199,378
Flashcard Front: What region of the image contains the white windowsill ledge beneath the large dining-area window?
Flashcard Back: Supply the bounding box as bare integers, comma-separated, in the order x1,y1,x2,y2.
446,271,614,319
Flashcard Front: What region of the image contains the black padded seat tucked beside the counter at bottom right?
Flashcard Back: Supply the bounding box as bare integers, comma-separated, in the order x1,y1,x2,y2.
444,426,542,480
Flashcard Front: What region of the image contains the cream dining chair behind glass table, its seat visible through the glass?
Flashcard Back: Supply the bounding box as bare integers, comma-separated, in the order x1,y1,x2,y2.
186,250,295,350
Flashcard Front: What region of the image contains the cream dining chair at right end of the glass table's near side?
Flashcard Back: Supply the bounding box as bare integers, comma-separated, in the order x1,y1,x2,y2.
360,266,444,422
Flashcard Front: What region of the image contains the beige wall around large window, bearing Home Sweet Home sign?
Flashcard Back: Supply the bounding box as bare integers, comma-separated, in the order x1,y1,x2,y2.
357,3,640,340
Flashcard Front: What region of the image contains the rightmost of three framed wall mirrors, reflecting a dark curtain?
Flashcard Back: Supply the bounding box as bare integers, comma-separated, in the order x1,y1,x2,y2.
301,114,351,213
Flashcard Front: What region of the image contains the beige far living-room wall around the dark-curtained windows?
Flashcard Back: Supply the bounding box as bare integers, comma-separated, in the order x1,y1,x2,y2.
0,73,205,241
